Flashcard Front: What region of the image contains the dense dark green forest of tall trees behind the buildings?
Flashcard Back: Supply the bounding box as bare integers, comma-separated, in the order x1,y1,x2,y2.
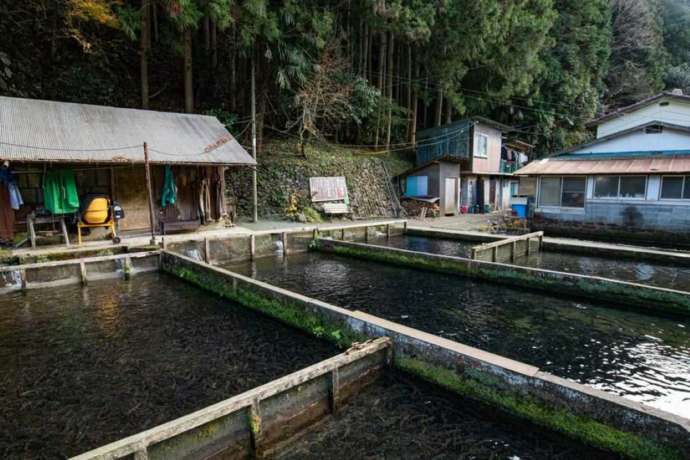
0,0,690,155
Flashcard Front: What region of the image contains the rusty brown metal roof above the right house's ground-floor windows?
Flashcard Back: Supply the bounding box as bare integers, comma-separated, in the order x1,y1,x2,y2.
515,155,690,176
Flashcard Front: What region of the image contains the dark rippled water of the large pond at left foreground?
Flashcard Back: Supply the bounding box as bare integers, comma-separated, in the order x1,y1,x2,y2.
0,273,338,458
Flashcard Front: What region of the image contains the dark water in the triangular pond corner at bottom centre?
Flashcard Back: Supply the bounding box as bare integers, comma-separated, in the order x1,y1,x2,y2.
276,372,618,460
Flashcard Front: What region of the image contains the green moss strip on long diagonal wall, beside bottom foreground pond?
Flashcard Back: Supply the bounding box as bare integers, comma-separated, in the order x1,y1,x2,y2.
395,357,683,460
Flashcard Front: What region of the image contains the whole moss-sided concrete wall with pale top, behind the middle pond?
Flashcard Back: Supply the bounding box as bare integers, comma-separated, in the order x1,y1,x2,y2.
315,239,690,316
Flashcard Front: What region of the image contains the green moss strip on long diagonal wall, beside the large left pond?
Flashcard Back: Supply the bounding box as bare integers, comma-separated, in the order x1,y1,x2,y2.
167,266,368,348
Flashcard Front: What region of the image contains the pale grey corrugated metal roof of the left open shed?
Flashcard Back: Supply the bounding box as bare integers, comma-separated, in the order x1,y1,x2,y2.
0,96,256,165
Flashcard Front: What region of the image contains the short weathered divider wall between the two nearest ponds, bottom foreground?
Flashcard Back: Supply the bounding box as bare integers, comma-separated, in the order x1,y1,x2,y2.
73,338,391,460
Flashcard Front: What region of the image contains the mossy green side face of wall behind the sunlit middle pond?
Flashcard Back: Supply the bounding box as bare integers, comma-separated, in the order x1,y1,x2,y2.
311,241,690,316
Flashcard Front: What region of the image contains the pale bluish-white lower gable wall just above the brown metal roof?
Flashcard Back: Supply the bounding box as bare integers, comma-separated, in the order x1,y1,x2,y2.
573,128,690,153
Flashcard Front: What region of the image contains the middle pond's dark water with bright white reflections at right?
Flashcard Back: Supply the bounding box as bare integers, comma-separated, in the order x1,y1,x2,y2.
227,252,690,418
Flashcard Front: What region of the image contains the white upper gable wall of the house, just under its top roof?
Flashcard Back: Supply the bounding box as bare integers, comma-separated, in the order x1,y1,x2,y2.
597,98,690,138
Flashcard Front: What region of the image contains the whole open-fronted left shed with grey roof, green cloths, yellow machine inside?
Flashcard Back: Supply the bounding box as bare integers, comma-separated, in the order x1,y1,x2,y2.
0,97,256,246
